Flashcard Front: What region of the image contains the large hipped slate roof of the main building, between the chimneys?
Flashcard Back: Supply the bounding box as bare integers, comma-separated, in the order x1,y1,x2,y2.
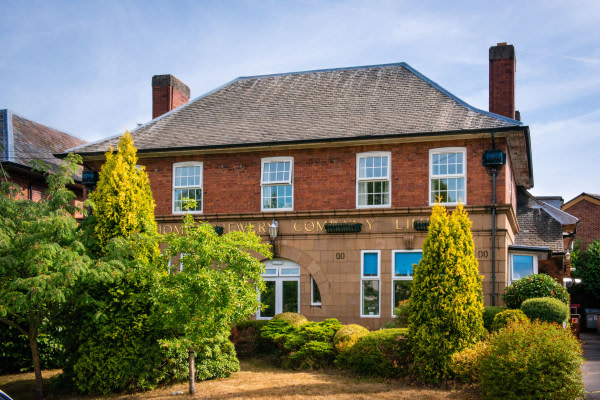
70,63,522,154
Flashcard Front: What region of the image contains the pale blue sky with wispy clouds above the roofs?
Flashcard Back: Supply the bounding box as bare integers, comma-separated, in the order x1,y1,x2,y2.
0,0,600,200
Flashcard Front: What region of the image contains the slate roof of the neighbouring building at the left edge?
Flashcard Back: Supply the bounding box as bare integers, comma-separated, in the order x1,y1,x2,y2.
0,110,86,172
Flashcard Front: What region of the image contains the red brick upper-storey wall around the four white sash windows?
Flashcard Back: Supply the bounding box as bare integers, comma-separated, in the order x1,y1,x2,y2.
116,139,510,216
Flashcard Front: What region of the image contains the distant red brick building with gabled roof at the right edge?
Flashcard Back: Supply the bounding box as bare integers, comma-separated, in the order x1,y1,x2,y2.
562,193,600,249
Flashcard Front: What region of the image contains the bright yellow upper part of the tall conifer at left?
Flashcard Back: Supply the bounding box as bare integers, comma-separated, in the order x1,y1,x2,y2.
90,132,157,252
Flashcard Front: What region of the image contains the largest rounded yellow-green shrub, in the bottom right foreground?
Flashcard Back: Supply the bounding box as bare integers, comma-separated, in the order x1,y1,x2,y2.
479,321,584,400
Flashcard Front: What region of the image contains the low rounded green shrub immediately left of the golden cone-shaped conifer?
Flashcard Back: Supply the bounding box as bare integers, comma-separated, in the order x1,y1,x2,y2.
336,328,411,377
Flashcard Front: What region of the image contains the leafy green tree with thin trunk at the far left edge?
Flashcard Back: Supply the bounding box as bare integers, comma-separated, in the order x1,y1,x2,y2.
0,155,110,397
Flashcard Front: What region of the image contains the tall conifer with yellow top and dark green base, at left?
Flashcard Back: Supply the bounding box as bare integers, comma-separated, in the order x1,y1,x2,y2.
63,132,162,393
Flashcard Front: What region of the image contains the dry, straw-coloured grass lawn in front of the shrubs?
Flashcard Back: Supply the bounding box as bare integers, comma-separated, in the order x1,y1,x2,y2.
0,361,477,400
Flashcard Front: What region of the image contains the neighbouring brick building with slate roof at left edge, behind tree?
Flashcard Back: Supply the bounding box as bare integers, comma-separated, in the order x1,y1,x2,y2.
0,109,86,201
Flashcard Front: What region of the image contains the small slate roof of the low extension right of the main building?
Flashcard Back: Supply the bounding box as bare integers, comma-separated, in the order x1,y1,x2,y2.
515,188,579,253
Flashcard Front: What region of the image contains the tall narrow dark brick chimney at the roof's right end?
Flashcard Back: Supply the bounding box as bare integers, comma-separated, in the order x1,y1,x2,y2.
490,43,517,119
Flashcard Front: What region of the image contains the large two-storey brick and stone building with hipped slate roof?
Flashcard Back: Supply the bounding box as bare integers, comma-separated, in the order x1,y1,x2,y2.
64,44,572,328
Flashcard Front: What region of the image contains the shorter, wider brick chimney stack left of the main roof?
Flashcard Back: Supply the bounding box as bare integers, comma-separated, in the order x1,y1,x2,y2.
152,75,190,119
